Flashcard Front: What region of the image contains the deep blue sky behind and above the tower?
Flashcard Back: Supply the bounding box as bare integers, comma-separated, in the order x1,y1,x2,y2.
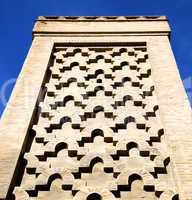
0,0,192,114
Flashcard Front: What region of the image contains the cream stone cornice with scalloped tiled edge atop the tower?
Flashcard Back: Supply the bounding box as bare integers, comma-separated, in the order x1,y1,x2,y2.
33,16,170,37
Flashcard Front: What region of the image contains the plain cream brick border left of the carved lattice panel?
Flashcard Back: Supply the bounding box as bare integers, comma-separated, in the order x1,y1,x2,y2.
0,37,53,199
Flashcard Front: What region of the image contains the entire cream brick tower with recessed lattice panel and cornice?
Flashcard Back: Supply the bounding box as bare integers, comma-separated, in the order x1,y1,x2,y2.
0,16,192,200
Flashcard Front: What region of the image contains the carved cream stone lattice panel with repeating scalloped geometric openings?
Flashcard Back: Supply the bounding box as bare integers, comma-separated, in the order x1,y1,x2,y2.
13,45,179,200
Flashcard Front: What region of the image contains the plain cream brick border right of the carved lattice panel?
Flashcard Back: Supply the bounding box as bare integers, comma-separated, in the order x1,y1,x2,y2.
148,37,192,200
